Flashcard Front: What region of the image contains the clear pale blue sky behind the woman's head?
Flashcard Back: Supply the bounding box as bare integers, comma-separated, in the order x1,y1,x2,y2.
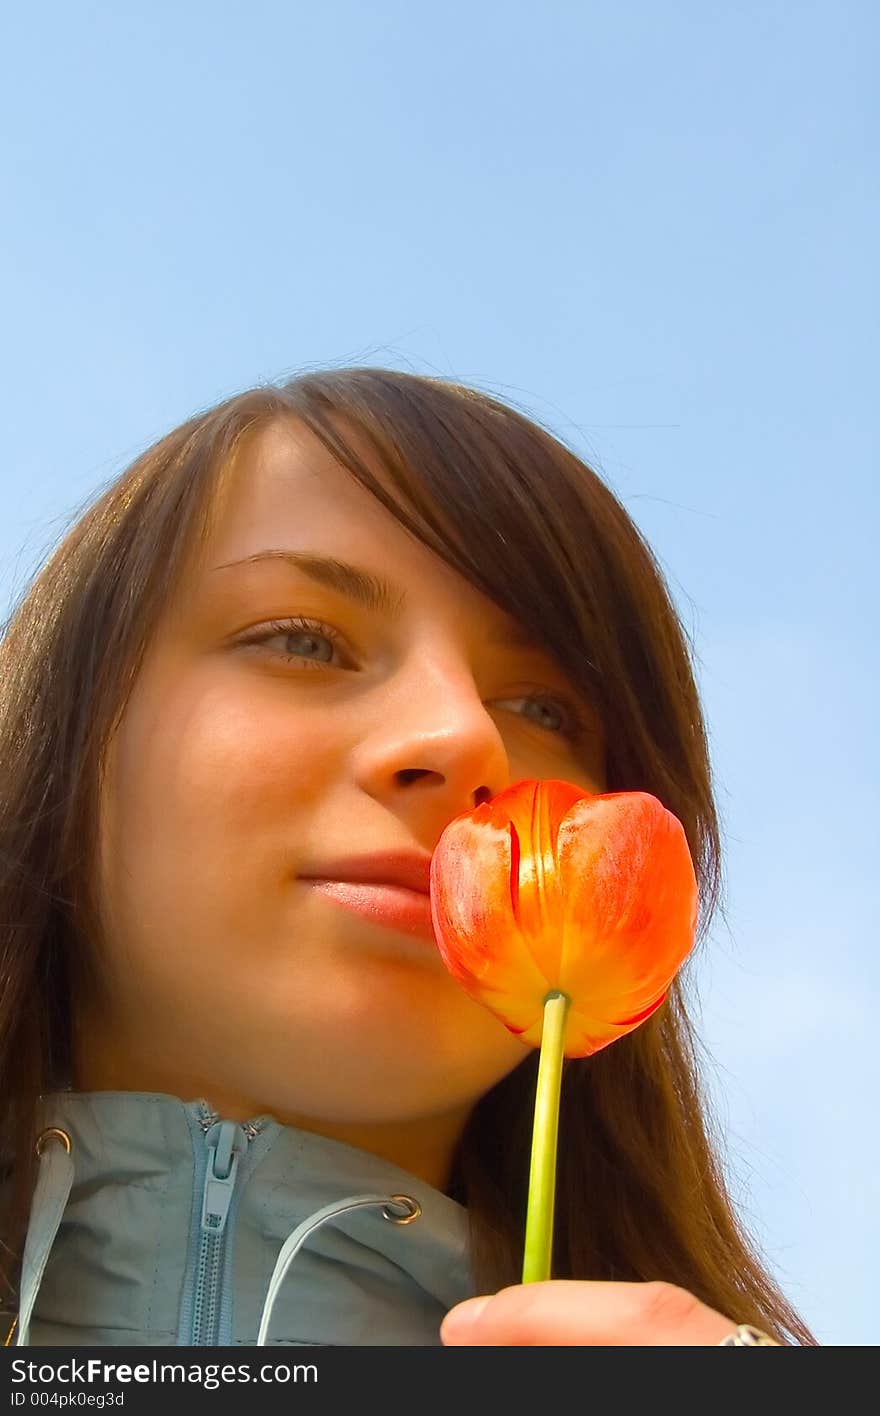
0,0,880,1345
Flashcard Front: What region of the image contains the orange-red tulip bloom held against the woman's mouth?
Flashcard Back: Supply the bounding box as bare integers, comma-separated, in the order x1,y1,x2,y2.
431,780,699,1056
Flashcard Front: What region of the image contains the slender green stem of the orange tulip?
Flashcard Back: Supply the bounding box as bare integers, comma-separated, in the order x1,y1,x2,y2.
523,993,571,1283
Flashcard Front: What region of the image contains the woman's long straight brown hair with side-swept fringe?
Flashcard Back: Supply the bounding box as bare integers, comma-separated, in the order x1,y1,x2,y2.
0,368,816,1345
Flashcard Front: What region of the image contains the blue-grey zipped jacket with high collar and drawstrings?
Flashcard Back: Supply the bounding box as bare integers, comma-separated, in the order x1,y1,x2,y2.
11,1092,475,1347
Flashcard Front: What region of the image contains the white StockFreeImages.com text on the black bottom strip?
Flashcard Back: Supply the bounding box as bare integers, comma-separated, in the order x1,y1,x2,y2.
11,1357,317,1387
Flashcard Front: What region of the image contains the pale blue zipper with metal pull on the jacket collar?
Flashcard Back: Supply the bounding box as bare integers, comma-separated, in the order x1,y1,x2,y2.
190,1109,262,1347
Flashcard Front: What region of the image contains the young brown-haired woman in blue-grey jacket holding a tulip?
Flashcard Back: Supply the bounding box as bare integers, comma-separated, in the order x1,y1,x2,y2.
0,368,815,1345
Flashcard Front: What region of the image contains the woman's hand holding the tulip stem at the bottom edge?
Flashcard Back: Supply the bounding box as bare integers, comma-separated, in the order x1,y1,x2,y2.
441,1279,738,1347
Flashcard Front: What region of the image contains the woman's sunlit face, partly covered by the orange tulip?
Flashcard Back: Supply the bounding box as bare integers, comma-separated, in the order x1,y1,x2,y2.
78,421,604,1144
